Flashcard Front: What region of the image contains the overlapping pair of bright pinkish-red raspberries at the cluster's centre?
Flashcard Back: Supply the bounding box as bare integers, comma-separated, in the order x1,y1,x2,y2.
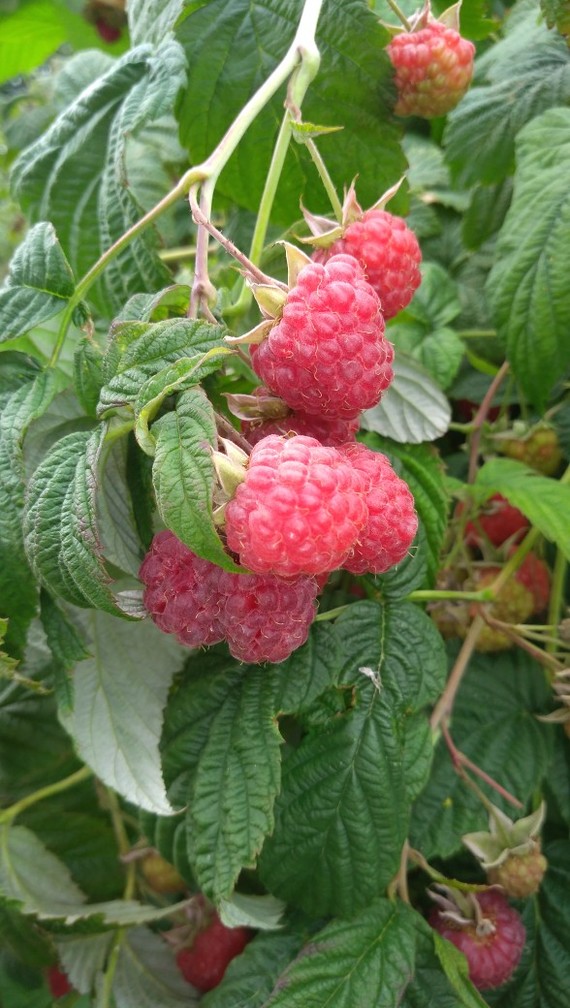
226,434,418,578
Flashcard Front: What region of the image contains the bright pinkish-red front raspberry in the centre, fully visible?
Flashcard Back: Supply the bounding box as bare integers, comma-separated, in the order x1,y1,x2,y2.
221,434,368,578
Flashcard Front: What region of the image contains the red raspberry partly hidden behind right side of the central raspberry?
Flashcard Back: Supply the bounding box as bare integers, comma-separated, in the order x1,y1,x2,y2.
334,445,418,574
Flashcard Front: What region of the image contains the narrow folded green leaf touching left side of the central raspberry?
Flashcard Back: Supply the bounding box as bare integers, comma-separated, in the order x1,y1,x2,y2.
152,388,240,571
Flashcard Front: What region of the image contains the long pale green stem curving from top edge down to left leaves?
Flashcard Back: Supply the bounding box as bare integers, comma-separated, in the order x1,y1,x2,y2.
49,0,323,367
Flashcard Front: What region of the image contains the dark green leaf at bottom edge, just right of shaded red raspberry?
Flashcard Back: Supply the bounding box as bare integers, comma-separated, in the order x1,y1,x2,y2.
201,931,303,1008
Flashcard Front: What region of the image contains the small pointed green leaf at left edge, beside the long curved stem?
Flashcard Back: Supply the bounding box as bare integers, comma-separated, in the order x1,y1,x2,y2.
0,224,75,342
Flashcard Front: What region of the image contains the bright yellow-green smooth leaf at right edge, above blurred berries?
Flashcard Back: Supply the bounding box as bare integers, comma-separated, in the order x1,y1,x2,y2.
475,459,570,559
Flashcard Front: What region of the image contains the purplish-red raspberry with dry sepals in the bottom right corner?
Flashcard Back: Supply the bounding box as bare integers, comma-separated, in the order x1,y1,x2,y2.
429,889,526,991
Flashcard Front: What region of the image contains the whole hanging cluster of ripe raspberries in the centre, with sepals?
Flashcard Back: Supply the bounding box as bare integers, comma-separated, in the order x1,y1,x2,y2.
140,210,420,662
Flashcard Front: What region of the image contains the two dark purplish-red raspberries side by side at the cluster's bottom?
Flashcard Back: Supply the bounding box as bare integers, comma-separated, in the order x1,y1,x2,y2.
139,531,319,663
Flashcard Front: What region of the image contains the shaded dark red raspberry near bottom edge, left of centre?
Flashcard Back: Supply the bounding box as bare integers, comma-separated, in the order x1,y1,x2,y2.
177,914,253,992
